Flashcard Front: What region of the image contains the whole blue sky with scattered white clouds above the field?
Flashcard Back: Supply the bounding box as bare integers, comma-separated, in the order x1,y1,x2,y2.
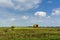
0,0,60,26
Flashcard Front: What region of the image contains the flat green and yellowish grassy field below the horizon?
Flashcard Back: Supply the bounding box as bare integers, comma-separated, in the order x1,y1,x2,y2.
0,28,60,40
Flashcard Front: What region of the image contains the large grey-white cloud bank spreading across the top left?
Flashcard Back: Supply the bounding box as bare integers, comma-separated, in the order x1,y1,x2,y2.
0,0,41,10
